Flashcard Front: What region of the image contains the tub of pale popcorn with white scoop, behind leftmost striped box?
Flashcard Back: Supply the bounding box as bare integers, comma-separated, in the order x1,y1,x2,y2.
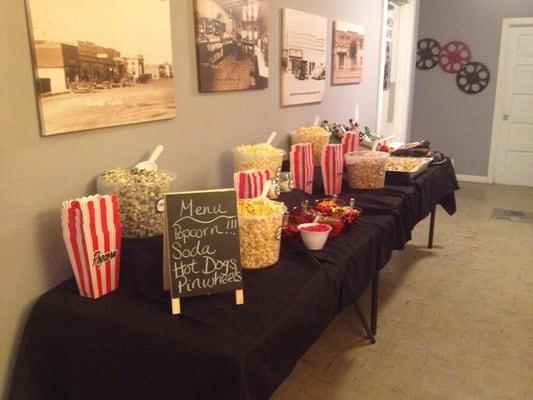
96,169,176,239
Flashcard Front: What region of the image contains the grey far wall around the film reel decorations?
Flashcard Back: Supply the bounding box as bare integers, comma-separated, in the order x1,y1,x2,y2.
411,0,533,176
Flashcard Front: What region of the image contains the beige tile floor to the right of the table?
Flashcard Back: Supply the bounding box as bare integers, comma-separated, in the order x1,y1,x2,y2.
272,183,533,400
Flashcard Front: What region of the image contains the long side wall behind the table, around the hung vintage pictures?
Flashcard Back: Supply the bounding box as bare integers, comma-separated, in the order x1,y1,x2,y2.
0,0,382,395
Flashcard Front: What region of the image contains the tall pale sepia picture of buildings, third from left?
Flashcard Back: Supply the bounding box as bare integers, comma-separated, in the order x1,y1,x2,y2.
281,8,328,106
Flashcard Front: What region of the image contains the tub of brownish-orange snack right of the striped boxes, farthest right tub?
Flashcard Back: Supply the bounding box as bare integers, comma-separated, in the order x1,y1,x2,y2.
344,151,389,189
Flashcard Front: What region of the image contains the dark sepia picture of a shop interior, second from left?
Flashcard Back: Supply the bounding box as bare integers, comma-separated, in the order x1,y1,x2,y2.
195,0,269,92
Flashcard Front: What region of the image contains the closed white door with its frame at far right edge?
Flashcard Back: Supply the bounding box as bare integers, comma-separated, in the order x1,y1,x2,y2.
493,18,533,186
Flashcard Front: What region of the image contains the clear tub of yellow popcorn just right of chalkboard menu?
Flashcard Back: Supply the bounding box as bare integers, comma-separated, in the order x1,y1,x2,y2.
238,199,287,269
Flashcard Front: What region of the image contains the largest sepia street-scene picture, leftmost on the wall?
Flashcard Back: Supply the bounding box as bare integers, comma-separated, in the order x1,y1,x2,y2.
26,0,176,136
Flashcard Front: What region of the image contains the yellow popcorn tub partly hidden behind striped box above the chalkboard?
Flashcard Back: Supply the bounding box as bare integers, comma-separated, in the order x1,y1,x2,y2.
233,143,286,178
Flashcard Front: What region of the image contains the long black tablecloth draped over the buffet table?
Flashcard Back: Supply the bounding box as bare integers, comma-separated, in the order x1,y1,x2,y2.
10,165,457,400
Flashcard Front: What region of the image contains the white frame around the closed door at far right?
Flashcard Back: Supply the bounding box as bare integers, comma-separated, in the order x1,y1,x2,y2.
488,18,533,184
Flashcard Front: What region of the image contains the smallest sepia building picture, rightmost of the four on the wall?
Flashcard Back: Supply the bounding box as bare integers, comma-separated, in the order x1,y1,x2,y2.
331,21,365,85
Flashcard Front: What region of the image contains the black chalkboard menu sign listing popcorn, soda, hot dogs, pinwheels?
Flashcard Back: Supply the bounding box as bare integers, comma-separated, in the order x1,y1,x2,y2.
164,189,243,314
